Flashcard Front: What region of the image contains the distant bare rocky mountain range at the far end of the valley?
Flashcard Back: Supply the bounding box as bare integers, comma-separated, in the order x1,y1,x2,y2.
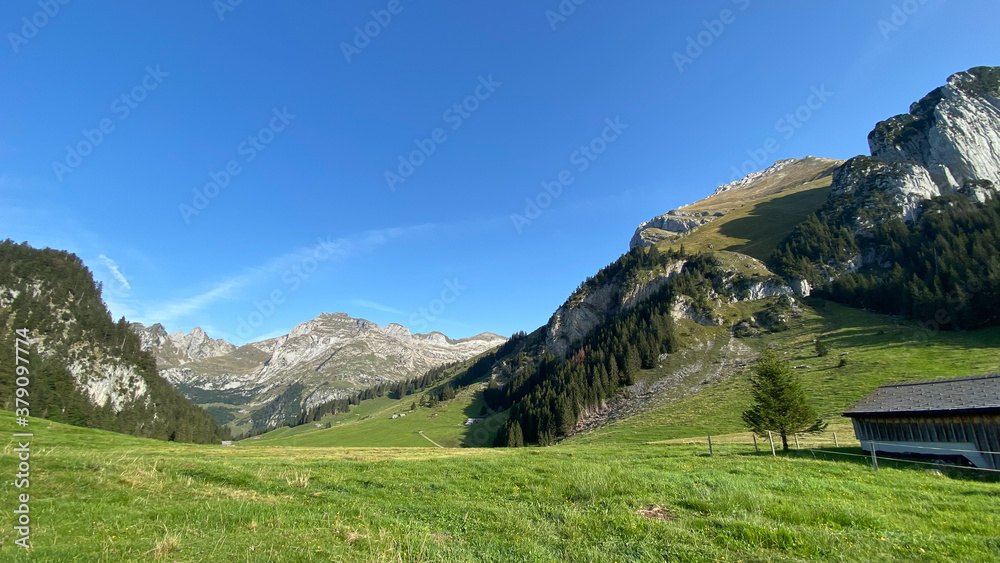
140,313,506,431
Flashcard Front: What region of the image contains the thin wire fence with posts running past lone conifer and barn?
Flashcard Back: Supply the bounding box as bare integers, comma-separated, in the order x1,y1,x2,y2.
668,429,1000,474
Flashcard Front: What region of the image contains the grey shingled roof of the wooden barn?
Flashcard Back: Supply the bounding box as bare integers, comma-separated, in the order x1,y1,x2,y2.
844,373,1000,416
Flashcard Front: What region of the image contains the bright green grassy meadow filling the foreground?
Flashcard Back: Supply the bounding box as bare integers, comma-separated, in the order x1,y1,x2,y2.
0,412,1000,563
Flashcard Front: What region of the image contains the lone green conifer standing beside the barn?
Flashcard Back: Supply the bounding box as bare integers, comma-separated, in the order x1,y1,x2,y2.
743,350,826,450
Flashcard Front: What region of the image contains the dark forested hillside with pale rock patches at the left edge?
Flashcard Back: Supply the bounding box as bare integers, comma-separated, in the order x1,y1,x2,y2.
0,240,229,442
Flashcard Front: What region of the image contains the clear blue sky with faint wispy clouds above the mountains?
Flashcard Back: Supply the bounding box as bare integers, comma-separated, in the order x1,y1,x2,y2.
0,0,1000,343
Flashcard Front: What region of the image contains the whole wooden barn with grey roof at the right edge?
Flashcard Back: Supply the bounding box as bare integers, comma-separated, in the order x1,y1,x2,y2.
844,374,1000,469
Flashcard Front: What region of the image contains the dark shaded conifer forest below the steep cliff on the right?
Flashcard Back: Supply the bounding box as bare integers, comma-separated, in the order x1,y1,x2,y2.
771,196,1000,329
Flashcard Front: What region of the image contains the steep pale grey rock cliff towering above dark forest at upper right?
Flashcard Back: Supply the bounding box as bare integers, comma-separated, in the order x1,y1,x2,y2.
831,67,1000,231
